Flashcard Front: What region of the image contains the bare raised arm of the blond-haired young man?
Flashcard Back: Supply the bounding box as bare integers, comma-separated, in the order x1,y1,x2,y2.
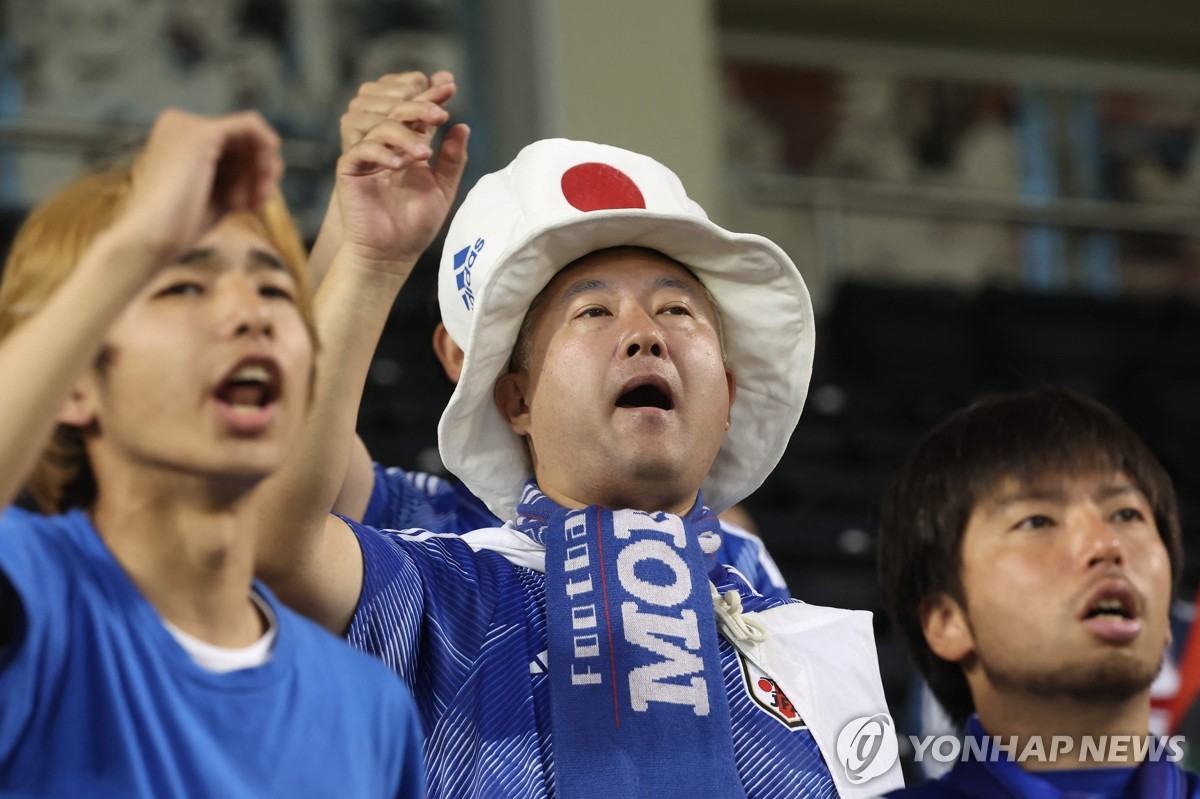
0,110,283,506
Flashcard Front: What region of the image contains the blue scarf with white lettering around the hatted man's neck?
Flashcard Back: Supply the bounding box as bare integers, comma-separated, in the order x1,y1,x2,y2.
516,482,745,799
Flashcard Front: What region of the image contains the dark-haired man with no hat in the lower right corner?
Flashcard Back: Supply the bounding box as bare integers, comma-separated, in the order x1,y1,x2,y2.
878,391,1198,797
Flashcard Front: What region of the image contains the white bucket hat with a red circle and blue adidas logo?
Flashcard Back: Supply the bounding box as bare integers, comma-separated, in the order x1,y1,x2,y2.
438,139,815,519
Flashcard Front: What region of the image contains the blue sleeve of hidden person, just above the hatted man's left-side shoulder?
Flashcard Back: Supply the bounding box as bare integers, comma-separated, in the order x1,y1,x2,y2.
362,463,496,534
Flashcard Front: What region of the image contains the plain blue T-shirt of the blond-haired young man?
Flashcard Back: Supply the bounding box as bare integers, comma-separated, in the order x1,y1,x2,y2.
0,509,424,799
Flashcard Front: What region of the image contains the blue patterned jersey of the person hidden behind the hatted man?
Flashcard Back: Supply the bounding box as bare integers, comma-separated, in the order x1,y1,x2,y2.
361,463,791,597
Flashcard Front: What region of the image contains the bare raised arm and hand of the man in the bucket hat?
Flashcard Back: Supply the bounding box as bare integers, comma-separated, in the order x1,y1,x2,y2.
258,101,468,632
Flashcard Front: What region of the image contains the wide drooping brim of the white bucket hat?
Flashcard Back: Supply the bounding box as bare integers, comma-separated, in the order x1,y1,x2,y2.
438,209,815,519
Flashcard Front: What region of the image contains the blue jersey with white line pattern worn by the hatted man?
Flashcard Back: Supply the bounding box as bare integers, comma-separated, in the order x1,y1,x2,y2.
347,515,836,799
